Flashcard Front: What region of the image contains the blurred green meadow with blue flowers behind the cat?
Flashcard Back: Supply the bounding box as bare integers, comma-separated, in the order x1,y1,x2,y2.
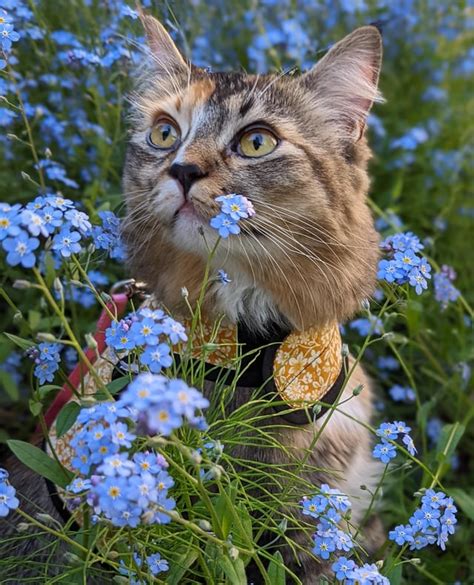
0,0,474,583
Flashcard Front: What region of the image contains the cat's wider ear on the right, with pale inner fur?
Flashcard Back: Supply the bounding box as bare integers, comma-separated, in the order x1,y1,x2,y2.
300,26,383,140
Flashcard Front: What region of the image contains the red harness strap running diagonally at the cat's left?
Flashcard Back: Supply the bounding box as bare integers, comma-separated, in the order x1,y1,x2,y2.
44,293,129,429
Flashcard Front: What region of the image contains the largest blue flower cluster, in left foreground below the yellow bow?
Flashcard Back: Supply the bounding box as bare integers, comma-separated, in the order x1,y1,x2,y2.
68,374,209,527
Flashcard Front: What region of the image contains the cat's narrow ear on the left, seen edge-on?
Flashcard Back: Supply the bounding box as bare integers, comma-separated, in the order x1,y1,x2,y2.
138,9,188,73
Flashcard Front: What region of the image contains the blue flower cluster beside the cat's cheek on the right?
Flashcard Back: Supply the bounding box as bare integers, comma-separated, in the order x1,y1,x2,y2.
377,232,431,295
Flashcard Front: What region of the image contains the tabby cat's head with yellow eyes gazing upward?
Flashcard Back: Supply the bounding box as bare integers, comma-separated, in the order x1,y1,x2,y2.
124,15,382,328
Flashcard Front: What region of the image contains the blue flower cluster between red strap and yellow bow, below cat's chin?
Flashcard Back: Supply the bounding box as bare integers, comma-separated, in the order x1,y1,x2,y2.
105,309,188,374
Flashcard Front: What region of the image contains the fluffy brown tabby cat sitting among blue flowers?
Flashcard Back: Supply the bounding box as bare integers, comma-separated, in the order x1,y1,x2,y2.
0,14,382,585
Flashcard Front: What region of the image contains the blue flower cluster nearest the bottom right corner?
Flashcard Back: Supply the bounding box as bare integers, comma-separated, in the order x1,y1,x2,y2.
389,489,457,550
